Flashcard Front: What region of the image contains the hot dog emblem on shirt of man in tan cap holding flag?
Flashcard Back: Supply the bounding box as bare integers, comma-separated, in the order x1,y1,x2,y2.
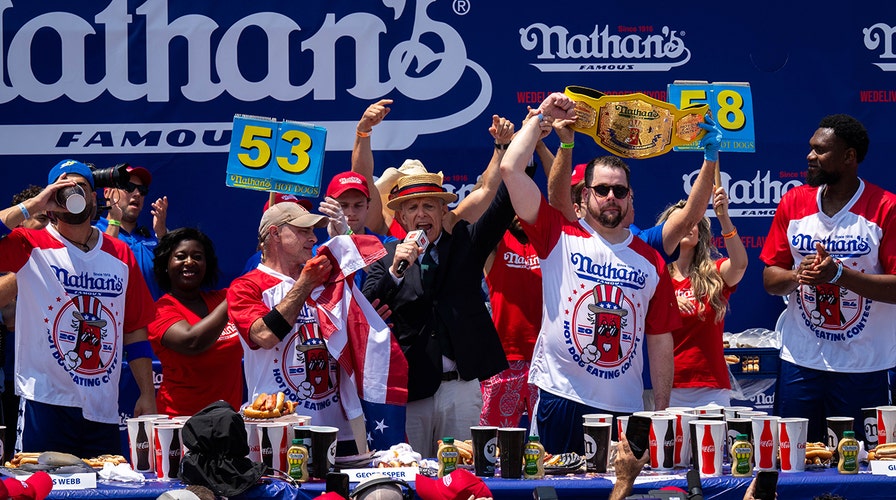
274,318,338,410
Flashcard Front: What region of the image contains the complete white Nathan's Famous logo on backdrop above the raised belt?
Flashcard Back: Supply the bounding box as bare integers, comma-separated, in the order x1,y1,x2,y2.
520,23,691,72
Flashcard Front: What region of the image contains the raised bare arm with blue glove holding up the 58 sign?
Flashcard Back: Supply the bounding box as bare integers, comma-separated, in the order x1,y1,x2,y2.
663,114,722,255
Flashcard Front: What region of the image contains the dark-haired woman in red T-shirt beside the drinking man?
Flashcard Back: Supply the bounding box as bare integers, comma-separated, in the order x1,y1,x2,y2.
149,228,243,416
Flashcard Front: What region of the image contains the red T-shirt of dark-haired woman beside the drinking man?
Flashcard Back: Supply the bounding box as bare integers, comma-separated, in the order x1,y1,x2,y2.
149,289,243,416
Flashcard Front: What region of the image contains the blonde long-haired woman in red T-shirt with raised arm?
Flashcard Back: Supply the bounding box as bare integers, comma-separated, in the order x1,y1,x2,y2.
659,187,747,406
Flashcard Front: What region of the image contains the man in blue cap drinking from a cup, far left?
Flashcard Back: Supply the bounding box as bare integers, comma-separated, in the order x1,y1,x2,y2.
0,160,156,457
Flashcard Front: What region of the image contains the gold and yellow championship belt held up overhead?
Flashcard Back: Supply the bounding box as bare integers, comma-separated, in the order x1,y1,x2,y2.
565,85,709,159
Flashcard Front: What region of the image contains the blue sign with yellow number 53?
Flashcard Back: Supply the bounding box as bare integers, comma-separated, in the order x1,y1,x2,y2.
227,115,327,198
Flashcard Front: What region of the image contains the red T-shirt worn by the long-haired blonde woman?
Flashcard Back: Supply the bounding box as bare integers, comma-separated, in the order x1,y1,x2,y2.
672,259,737,389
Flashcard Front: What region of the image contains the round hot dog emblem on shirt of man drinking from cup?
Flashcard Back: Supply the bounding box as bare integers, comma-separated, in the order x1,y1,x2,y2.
51,295,119,382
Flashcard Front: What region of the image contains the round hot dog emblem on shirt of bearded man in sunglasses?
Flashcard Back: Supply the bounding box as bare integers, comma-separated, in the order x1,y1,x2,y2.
564,284,640,378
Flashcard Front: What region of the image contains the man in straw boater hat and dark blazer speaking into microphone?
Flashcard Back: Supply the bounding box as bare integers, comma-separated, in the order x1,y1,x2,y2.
364,173,514,457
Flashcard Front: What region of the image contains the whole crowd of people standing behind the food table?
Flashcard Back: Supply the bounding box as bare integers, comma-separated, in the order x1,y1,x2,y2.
0,94,896,496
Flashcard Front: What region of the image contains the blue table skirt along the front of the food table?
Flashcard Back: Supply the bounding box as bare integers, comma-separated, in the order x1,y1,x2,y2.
43,469,896,500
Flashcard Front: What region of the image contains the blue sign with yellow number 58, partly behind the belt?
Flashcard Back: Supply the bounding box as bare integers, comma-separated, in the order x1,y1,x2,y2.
667,80,756,153
